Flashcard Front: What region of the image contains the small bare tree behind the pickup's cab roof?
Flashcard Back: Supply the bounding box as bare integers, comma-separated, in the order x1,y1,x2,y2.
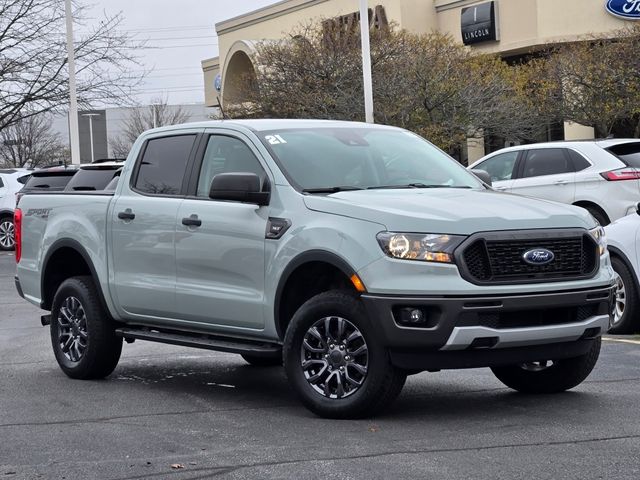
109,98,189,158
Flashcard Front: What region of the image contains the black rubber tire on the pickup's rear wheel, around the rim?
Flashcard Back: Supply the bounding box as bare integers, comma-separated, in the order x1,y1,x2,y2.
51,276,122,380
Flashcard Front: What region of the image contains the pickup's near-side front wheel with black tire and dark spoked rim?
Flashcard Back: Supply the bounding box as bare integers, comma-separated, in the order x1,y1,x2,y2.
283,290,406,418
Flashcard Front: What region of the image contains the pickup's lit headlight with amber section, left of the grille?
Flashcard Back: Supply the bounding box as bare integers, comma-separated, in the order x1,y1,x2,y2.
377,232,465,263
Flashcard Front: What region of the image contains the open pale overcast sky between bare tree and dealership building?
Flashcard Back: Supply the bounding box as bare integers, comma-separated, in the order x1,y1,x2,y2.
82,0,277,104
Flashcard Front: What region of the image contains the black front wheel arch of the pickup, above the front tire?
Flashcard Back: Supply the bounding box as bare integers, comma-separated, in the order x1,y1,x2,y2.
273,250,356,340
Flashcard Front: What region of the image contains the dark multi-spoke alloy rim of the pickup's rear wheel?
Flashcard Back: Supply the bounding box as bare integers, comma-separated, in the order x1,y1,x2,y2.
57,297,89,362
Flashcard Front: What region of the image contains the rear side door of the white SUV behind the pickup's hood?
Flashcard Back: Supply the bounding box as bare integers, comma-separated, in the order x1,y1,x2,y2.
512,148,576,203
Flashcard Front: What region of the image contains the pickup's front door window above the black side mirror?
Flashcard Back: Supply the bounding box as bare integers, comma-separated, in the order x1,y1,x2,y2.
196,135,266,198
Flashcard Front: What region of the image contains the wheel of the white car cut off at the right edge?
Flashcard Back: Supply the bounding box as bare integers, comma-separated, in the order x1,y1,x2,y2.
609,256,638,334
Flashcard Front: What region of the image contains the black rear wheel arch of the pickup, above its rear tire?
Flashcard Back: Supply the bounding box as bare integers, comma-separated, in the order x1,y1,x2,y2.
40,239,109,313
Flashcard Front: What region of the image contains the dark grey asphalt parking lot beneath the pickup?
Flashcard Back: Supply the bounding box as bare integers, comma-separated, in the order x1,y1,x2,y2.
0,254,640,480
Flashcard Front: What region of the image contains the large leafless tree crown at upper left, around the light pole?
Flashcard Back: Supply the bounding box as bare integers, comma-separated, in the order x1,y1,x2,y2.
0,0,143,130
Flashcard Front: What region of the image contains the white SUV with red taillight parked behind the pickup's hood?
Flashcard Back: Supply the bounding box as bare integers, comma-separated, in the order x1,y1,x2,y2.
469,139,640,225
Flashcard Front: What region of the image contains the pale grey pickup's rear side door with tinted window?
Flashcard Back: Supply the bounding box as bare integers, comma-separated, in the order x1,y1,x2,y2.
110,132,198,321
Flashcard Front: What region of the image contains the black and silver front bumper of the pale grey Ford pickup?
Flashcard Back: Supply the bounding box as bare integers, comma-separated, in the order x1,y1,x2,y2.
362,285,614,368
